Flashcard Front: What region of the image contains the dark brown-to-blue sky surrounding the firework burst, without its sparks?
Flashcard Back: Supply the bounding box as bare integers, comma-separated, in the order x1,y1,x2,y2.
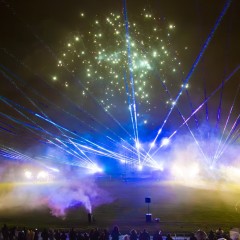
0,0,240,165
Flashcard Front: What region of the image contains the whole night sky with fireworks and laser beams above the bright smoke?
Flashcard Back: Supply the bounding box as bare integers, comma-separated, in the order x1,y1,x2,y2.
0,0,240,172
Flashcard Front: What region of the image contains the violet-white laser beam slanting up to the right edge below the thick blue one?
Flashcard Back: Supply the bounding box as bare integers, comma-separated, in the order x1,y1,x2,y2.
151,65,240,156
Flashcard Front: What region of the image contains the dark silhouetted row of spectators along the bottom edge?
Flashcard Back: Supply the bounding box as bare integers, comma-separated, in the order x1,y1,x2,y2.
0,224,237,240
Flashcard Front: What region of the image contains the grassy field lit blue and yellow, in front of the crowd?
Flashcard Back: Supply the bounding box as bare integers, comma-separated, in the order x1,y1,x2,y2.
0,179,240,234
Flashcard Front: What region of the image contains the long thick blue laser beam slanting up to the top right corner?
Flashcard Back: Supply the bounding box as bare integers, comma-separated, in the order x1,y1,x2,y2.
149,0,232,152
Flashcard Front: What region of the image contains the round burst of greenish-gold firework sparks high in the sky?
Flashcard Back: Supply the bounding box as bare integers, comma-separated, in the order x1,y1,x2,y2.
56,9,185,115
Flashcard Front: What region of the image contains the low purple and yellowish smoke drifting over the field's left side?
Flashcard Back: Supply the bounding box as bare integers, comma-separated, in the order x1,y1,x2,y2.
0,163,112,218
